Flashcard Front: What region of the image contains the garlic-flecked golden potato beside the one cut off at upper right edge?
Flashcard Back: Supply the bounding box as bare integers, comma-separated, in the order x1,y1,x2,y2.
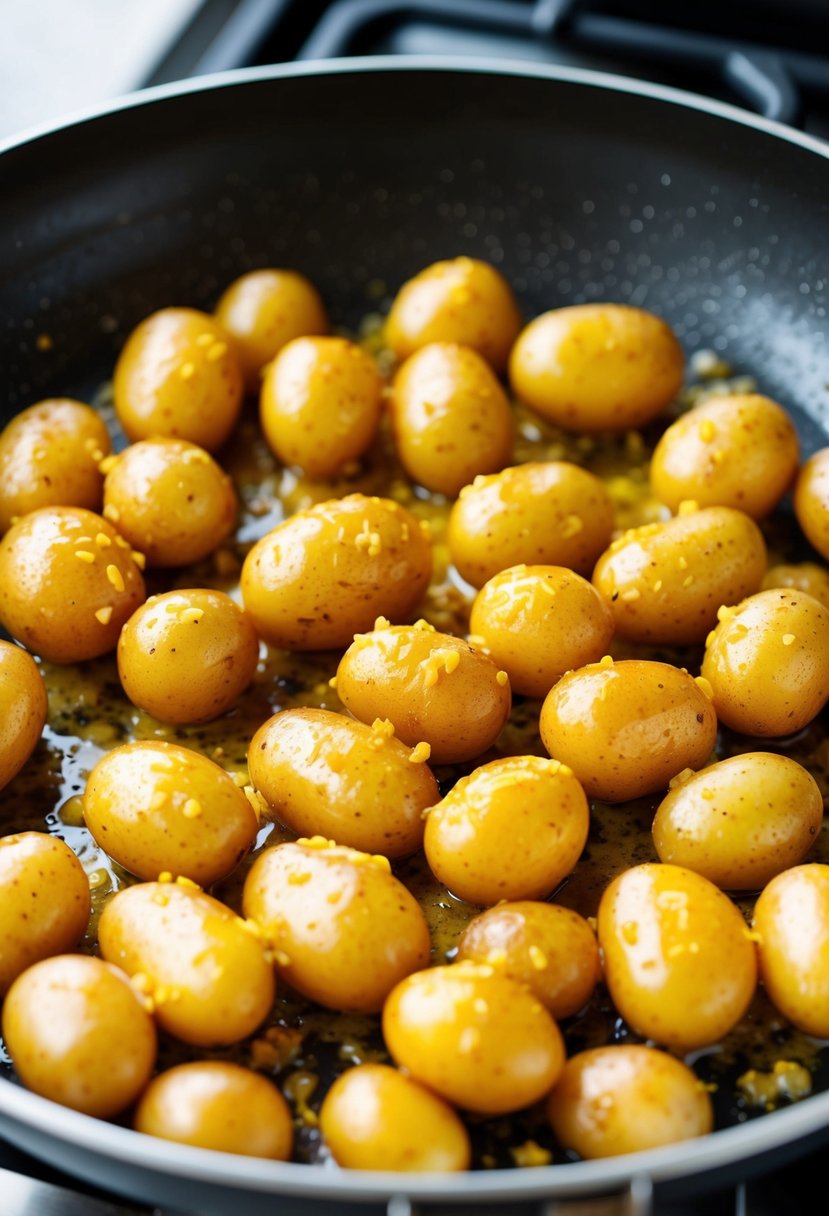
650,393,799,519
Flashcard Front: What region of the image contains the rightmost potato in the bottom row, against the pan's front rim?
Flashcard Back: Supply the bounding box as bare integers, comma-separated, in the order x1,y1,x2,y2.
547,1043,714,1161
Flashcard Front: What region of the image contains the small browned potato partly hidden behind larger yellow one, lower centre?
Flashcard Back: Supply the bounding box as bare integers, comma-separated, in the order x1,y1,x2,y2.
458,900,602,1019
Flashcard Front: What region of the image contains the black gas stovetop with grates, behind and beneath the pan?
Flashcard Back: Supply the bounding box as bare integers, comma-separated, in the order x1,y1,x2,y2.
0,0,829,1216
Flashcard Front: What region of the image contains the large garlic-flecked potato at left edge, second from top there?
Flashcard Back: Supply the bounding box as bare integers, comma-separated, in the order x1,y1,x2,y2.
0,507,145,663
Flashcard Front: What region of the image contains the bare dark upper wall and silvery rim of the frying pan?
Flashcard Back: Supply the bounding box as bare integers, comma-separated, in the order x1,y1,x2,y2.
0,58,829,1216
